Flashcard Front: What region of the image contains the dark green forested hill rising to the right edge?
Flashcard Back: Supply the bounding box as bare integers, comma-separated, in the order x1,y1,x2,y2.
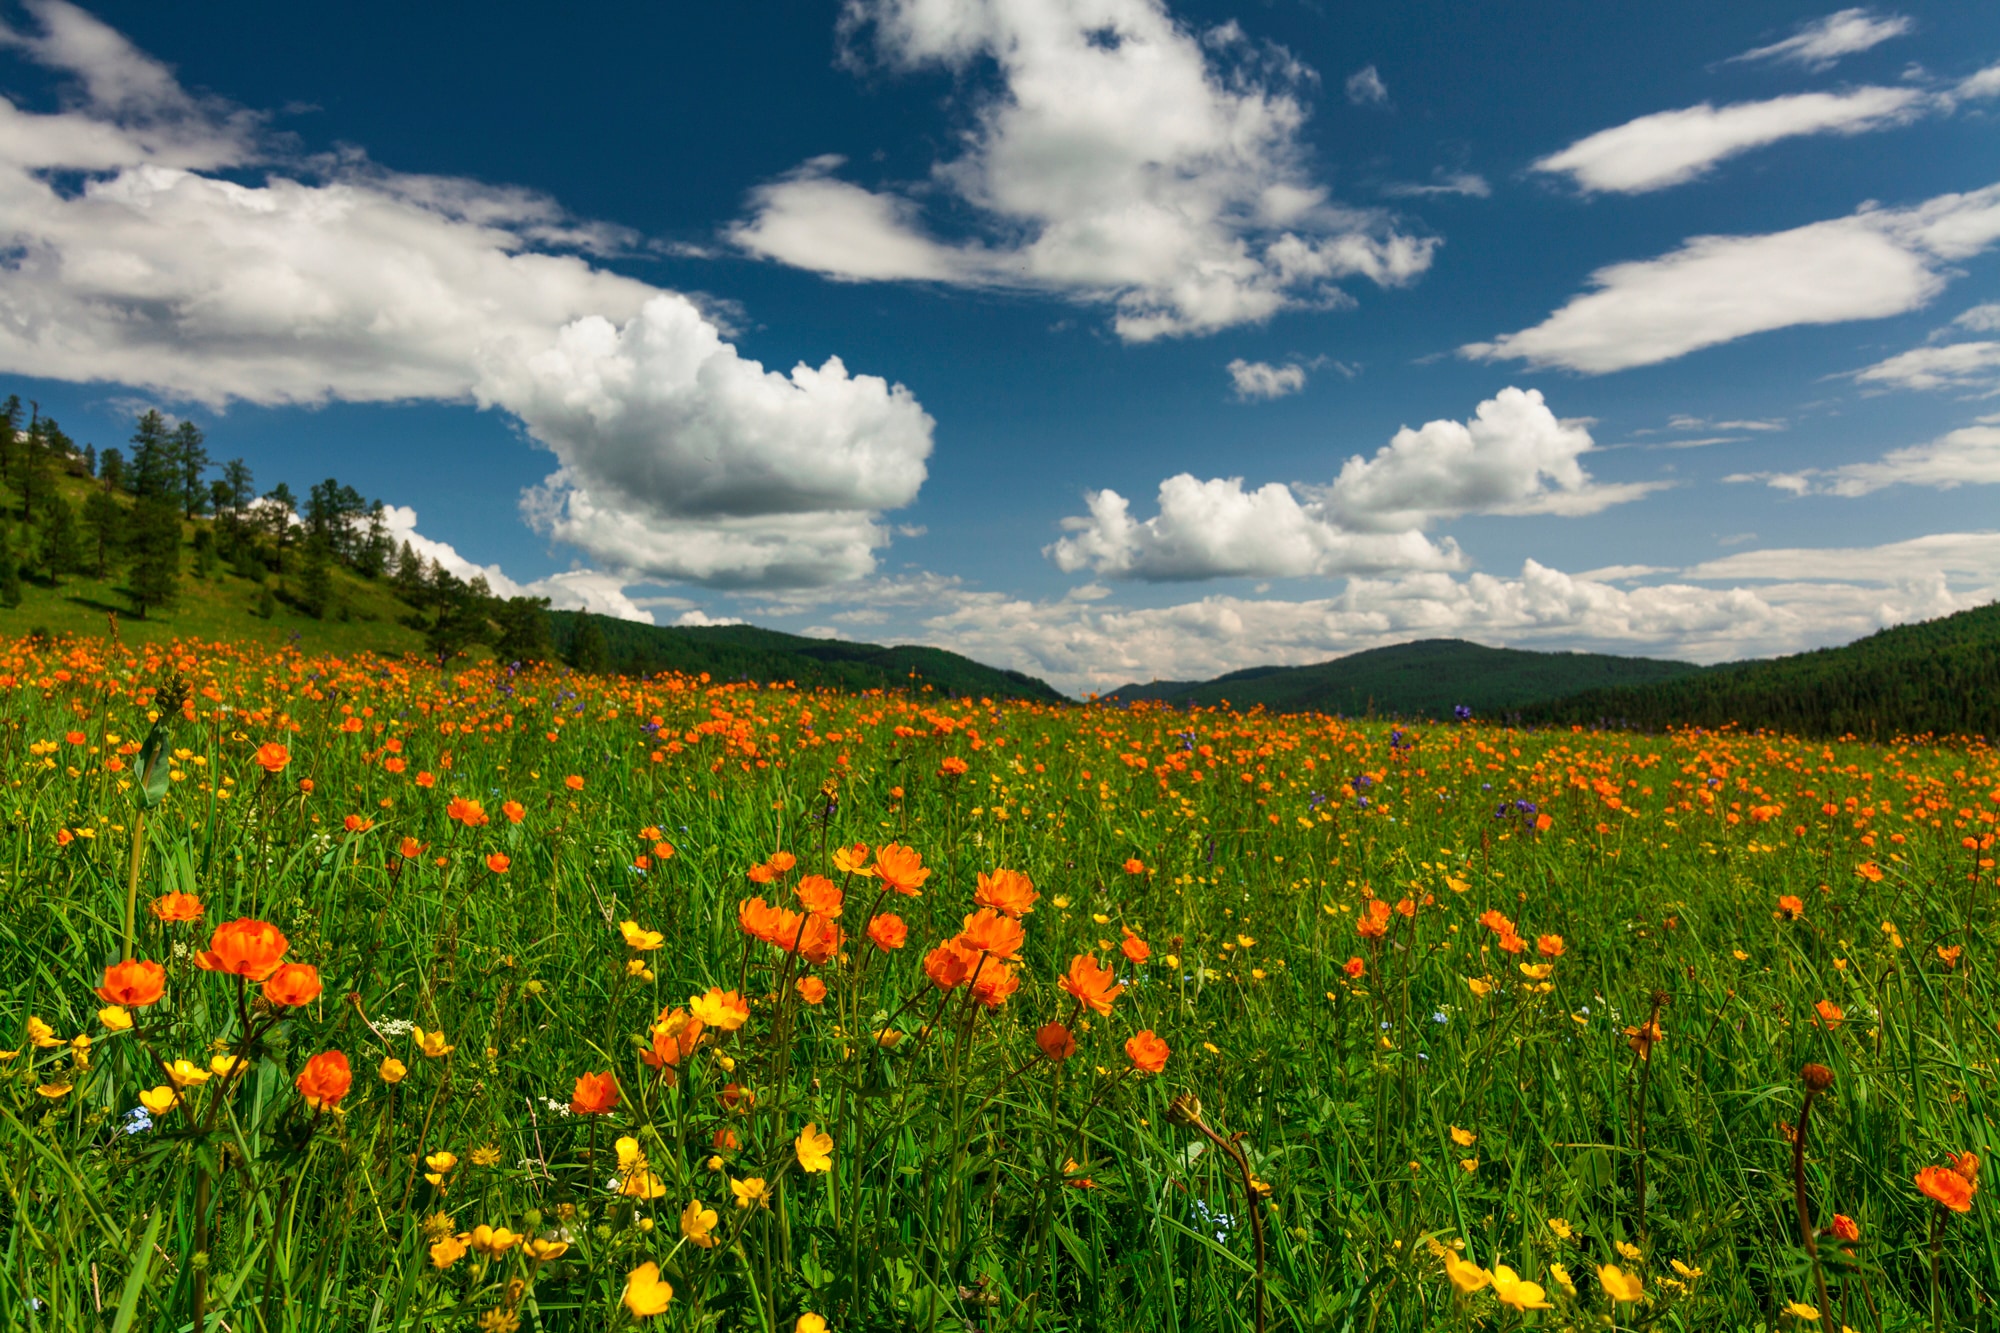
1522,602,2000,741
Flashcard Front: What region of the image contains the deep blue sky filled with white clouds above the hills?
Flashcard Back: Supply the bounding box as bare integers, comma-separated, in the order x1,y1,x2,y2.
0,0,2000,695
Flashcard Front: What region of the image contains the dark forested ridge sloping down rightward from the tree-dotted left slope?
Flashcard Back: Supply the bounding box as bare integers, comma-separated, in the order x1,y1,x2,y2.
550,610,1062,701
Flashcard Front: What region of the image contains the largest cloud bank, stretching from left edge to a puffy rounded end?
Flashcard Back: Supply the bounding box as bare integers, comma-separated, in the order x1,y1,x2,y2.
0,0,932,584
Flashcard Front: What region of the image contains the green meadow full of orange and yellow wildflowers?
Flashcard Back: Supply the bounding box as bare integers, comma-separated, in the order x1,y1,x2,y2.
0,640,2000,1333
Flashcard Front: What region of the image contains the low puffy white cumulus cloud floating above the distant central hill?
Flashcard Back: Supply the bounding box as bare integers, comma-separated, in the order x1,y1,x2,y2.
1046,378,1656,580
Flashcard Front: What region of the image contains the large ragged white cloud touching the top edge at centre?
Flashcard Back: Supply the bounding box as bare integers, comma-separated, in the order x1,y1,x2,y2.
730,0,1436,340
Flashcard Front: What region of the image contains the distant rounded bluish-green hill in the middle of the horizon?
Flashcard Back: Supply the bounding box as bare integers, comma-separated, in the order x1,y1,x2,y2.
1106,638,1700,719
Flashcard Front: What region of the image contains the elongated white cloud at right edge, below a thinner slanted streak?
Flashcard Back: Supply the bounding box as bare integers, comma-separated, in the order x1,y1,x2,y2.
1460,186,2000,374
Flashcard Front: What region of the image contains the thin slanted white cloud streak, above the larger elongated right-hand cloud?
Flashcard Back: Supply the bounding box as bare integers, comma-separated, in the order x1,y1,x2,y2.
1534,88,1930,194
